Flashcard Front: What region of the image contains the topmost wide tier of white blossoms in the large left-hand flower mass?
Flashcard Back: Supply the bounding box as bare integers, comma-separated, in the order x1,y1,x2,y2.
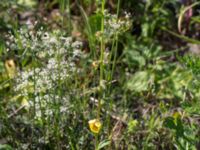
6,29,82,58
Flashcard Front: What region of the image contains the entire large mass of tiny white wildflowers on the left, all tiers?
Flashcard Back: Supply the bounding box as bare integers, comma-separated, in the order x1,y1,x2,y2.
6,27,87,118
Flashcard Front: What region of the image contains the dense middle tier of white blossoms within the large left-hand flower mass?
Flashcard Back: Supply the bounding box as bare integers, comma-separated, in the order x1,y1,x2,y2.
15,58,74,96
